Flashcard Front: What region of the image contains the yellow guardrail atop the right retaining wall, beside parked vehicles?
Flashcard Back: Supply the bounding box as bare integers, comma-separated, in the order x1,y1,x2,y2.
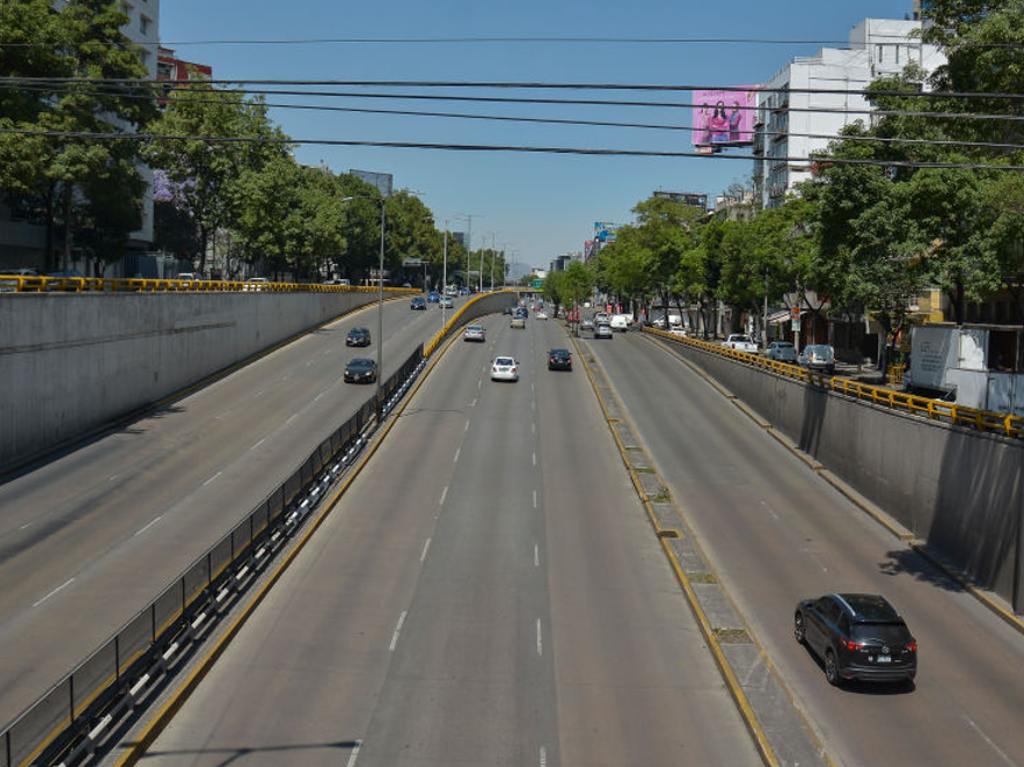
643,328,1024,439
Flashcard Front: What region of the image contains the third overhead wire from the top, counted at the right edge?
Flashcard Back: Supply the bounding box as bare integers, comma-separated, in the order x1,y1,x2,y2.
6,80,1024,122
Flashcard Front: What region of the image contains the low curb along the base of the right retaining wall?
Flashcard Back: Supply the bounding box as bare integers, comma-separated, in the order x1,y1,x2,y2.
643,333,1024,634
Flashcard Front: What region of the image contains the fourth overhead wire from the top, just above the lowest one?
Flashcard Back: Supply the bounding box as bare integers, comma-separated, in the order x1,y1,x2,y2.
8,84,1024,151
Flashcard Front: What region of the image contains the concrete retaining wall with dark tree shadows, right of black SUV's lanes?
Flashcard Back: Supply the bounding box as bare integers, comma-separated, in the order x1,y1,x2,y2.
655,335,1024,611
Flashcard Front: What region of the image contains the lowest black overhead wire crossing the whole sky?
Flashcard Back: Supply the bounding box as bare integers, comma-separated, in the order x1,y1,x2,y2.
0,128,1024,171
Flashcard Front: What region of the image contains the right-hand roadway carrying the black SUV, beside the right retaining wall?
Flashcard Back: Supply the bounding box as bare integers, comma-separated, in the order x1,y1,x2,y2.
585,333,1024,767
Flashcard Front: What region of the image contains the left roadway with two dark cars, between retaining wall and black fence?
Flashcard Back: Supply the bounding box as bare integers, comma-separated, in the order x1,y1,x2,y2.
0,299,452,722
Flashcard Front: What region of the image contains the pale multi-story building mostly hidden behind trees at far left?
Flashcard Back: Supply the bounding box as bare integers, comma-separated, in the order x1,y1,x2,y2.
0,0,160,273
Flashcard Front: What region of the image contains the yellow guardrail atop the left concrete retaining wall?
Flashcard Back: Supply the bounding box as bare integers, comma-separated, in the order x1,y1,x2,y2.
0,274,420,295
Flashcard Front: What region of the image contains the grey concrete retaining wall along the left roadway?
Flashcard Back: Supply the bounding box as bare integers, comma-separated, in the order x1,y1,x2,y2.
0,293,385,471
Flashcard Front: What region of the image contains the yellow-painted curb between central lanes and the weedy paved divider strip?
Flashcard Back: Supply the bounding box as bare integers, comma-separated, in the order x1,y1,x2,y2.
569,336,781,767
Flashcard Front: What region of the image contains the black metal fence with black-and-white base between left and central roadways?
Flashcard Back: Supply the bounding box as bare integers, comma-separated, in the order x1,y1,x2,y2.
0,344,426,767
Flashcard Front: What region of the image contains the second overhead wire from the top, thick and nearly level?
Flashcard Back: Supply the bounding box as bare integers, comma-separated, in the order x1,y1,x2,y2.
9,77,1024,101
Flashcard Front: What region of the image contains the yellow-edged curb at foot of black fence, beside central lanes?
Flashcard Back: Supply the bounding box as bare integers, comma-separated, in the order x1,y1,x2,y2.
114,337,455,767
